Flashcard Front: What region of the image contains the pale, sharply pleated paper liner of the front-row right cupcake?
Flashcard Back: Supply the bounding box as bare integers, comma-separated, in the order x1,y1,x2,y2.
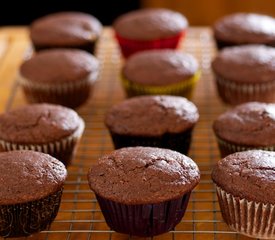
217,186,275,239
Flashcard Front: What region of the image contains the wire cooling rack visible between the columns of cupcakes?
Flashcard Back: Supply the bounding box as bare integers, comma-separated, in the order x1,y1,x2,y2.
2,28,258,240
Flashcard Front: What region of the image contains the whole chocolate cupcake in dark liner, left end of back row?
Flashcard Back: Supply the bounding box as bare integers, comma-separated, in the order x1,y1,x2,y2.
30,12,102,53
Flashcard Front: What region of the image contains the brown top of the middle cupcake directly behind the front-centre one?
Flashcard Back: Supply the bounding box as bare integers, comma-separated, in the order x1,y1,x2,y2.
105,95,199,136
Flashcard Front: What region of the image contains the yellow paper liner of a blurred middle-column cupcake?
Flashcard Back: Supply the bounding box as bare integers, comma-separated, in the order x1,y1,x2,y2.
121,71,200,99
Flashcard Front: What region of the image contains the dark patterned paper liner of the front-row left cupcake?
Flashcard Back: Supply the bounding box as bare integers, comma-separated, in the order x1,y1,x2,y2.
0,188,63,238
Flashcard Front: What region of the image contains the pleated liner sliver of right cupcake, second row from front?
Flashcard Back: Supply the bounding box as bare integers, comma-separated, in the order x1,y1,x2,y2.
216,136,275,158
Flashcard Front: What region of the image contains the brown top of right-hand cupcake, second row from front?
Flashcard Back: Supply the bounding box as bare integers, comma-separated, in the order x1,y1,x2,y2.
213,102,275,147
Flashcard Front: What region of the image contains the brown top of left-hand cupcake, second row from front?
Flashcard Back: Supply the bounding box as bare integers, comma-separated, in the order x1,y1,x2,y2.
0,104,84,144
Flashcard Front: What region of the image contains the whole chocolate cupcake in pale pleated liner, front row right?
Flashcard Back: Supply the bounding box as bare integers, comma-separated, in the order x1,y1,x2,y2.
212,150,275,239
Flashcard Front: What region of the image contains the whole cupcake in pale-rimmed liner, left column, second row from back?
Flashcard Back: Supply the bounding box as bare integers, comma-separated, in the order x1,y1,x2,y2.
19,49,99,108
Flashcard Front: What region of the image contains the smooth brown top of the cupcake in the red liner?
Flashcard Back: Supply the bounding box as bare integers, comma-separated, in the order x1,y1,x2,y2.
113,8,188,41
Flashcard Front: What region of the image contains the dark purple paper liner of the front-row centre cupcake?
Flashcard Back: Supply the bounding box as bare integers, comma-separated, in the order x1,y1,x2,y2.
96,192,190,237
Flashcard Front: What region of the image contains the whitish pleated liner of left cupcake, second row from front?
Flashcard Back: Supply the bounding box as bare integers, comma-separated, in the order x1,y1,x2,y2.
0,118,85,164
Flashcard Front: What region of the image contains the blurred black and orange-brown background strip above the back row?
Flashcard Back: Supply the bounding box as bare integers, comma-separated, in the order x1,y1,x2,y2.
0,0,275,25
